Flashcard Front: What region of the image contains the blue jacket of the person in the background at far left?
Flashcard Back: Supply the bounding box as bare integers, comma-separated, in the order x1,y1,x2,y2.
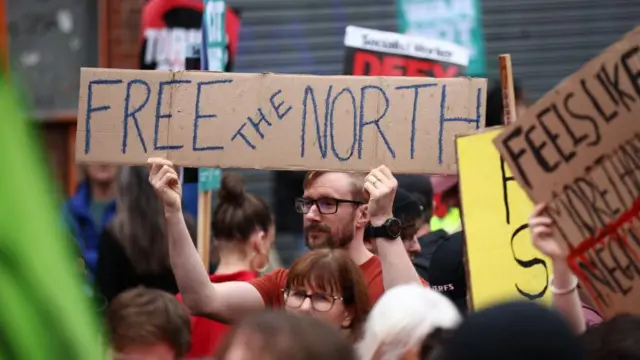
63,181,116,277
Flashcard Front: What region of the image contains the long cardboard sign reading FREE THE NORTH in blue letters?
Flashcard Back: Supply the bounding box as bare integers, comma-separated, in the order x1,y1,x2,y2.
76,68,486,174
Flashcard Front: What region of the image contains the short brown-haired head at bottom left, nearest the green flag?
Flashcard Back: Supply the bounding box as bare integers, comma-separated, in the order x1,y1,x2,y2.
106,287,191,360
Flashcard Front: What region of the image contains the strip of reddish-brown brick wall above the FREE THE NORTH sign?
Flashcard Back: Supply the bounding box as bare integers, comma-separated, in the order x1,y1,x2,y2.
101,0,145,69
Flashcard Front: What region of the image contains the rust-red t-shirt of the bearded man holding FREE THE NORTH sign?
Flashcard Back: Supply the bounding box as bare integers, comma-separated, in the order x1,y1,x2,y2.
249,256,427,308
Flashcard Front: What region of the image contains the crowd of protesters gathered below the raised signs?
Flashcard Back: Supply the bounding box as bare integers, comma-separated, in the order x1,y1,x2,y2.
64,82,640,360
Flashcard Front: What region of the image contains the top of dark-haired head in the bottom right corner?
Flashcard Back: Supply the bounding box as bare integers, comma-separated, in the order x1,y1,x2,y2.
581,314,640,360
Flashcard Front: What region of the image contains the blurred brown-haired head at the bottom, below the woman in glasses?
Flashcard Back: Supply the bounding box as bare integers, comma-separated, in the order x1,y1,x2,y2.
216,311,355,360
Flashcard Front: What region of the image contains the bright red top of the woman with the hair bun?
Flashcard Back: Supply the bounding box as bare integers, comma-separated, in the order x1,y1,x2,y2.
177,271,256,359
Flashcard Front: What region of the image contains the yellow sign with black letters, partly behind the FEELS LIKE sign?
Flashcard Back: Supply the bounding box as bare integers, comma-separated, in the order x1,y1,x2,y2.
456,129,551,310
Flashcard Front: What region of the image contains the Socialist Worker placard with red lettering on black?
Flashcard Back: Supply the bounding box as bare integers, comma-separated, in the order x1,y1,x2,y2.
344,26,469,78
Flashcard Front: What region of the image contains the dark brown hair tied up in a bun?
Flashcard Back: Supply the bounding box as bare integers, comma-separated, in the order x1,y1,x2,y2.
211,172,273,241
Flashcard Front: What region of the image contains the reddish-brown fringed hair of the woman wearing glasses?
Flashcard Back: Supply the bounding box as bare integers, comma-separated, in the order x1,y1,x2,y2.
286,249,371,342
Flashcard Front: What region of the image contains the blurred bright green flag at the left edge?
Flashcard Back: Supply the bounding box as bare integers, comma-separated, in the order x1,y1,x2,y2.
0,81,104,360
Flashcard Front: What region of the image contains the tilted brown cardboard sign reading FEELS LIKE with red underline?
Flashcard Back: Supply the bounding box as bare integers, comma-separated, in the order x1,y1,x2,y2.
495,27,640,317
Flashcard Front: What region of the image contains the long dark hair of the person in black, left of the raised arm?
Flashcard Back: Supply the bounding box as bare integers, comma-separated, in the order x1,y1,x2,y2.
108,166,192,273
